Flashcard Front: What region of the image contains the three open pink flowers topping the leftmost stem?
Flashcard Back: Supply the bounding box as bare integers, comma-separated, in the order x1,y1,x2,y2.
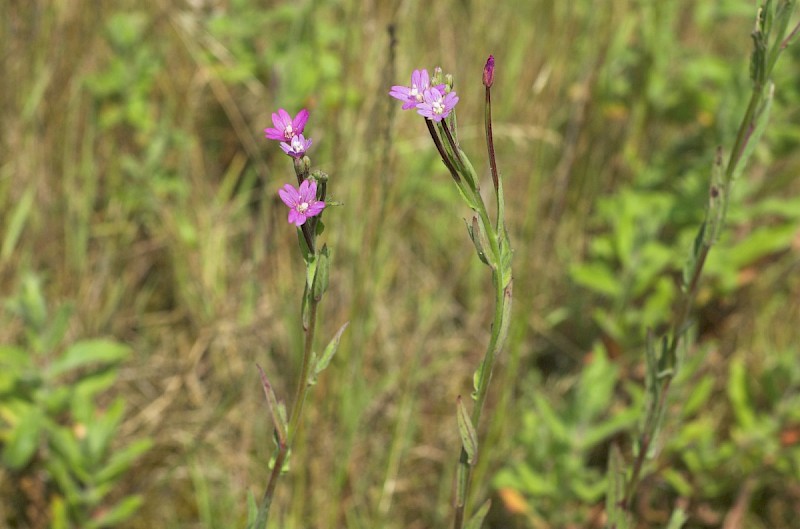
264,108,325,227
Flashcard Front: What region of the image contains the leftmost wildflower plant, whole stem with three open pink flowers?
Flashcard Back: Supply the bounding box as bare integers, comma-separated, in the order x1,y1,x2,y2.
247,109,347,529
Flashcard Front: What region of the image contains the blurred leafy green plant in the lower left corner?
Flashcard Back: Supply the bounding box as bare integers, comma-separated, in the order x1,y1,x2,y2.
0,276,152,528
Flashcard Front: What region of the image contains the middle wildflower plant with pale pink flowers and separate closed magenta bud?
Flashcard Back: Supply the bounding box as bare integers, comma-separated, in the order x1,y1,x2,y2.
389,56,512,529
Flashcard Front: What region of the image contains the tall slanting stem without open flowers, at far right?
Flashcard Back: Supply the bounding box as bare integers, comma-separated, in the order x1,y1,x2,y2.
606,0,800,529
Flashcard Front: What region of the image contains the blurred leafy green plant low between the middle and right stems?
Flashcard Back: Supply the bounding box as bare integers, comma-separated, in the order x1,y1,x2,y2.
494,348,641,527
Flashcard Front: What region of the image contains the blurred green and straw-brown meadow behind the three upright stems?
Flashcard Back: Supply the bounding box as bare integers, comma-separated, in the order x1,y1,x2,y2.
0,0,800,529
